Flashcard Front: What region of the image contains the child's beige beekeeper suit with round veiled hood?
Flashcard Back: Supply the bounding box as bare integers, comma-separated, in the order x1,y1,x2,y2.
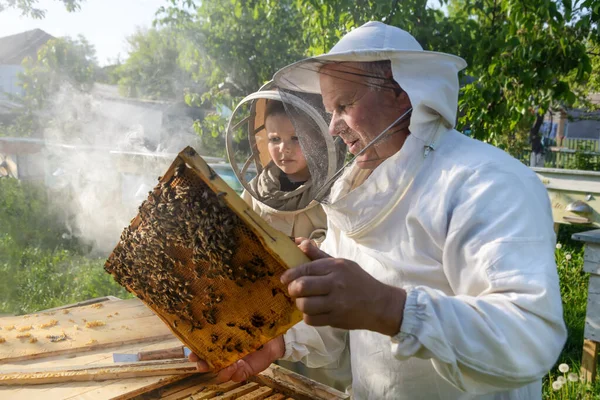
227,82,351,390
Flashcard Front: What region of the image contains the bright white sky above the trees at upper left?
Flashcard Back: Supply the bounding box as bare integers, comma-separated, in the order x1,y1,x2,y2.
0,0,167,66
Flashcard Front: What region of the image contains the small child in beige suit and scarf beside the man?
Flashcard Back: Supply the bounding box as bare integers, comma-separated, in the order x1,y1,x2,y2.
229,91,351,391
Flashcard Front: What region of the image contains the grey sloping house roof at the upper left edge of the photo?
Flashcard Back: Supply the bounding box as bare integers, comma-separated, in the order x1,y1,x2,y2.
0,29,54,65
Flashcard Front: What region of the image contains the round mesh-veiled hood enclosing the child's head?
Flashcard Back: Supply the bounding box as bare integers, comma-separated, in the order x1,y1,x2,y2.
226,83,346,212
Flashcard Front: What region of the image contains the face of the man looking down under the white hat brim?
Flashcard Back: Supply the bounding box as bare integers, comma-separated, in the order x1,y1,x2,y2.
319,63,410,169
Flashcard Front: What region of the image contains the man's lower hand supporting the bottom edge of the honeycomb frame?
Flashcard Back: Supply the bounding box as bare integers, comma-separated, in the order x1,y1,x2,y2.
188,336,285,382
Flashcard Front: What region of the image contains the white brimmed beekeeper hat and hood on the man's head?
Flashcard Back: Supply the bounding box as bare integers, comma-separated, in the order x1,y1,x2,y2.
274,22,466,203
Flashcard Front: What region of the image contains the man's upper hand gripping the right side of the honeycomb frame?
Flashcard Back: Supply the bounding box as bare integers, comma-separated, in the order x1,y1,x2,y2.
281,238,406,336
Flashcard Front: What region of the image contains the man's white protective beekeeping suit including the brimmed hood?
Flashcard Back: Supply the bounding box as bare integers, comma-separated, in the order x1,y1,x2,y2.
275,22,566,400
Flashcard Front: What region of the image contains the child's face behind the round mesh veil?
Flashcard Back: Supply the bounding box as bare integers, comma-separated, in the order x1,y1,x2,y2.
265,114,310,181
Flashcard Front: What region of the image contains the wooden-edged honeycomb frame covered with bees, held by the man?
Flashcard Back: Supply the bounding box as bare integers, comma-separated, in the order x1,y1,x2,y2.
105,147,308,369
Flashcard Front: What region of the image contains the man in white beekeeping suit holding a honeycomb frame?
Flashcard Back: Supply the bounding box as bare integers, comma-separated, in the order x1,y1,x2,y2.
193,22,566,399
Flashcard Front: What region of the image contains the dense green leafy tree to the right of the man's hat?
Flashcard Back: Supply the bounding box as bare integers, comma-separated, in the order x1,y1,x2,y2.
449,0,600,165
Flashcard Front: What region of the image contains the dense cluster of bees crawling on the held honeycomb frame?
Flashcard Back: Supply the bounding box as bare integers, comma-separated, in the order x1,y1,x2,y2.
105,163,273,329
